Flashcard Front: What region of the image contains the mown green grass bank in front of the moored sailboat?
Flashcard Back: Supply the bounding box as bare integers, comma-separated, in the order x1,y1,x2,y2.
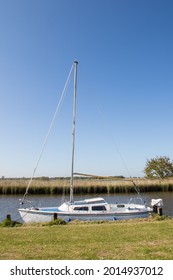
0,218,173,260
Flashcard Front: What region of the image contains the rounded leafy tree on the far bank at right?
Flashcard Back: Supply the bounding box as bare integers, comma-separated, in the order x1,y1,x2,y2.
144,156,173,179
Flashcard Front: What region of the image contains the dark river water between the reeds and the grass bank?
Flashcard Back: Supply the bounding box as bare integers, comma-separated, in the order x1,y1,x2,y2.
0,192,173,222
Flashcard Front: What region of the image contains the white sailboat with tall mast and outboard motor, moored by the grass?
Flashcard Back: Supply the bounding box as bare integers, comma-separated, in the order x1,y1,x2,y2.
19,61,163,223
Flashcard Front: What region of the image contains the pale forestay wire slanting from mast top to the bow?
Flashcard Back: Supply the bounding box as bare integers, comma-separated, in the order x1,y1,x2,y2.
20,62,74,204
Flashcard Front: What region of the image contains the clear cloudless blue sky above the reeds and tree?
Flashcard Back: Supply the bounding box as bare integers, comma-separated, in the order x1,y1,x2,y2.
0,0,173,177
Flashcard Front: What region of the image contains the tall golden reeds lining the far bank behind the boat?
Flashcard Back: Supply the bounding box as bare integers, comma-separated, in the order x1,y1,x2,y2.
0,177,173,195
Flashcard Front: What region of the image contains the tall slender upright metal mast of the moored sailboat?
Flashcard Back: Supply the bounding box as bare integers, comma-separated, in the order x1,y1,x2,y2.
70,61,78,202
